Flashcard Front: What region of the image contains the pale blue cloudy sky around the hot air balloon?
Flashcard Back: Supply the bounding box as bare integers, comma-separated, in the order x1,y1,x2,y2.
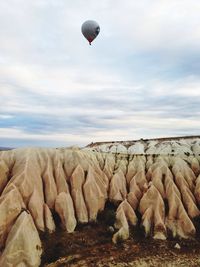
0,0,200,147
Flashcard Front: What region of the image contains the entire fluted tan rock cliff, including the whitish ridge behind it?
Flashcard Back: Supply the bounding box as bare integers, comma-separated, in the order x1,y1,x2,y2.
0,138,200,267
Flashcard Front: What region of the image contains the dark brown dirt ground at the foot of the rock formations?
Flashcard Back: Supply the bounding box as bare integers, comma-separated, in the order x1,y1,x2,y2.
41,210,200,267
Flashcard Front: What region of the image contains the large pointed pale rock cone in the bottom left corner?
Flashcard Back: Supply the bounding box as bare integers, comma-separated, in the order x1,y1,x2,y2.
0,211,42,267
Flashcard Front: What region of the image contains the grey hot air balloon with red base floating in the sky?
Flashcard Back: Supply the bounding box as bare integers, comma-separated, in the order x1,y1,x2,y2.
81,20,100,45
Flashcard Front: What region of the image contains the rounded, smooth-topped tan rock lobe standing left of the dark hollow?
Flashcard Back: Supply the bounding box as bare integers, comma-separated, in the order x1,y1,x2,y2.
55,192,76,233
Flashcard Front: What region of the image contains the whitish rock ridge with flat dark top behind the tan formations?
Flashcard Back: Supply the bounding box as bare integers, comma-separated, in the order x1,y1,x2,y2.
85,136,200,156
